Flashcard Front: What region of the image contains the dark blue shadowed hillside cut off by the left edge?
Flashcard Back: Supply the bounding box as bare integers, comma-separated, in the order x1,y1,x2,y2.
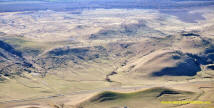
0,40,33,78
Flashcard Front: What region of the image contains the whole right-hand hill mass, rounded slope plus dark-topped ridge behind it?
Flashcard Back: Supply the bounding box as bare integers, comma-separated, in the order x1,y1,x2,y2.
109,32,214,83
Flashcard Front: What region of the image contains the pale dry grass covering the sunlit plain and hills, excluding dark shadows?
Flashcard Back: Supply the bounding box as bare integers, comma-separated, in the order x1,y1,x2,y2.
0,6,214,108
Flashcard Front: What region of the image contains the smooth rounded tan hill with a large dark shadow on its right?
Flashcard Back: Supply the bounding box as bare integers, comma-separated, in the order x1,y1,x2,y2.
113,50,201,77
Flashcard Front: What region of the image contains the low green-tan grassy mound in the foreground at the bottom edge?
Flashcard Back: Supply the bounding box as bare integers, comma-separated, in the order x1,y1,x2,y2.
78,87,195,108
